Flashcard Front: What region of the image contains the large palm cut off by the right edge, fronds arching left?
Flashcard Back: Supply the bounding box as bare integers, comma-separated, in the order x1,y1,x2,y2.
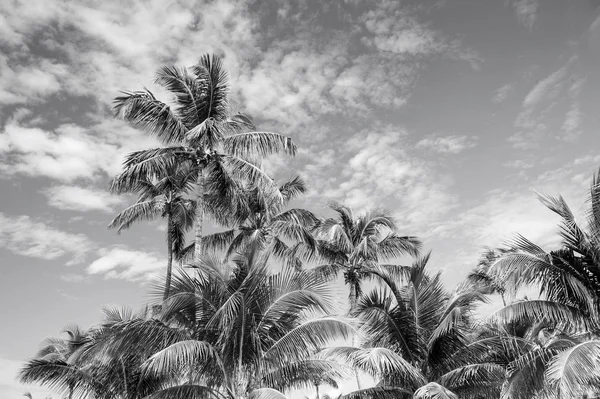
480,170,600,398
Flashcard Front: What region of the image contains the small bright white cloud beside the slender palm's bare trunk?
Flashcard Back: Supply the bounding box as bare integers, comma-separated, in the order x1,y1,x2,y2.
87,247,167,282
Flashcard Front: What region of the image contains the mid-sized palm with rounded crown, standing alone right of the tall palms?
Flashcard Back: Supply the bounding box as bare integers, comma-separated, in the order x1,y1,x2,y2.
292,203,421,314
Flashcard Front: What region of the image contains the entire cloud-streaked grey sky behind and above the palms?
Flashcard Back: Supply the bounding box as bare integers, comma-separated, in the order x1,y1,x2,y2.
0,0,600,399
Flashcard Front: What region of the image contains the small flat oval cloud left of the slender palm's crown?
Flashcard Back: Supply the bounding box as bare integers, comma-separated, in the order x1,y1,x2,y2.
44,185,123,213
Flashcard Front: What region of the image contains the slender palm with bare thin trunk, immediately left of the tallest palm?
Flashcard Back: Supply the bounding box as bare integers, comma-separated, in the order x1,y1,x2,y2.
108,165,195,299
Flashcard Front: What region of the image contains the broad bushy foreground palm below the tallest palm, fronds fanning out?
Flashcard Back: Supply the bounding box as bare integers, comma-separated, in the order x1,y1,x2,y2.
70,249,353,399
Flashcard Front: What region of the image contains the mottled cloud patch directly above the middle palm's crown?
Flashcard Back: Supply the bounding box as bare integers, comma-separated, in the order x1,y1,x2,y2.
300,127,456,235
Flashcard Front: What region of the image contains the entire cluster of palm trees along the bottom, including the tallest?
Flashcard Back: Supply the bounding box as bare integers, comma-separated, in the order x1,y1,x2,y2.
19,55,600,399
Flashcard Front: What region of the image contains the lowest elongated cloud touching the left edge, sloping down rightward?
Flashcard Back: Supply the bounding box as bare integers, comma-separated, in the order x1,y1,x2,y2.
0,213,95,263
